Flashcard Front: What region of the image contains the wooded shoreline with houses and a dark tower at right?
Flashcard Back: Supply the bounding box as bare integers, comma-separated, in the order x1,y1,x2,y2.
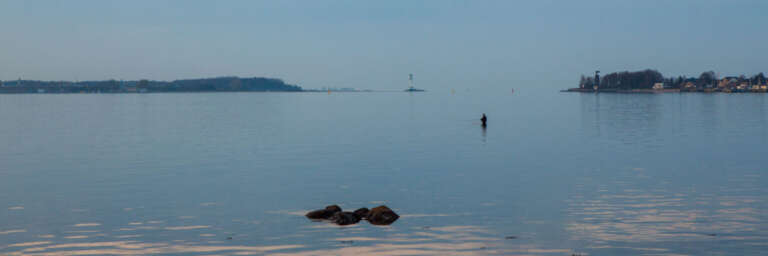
563,69,768,93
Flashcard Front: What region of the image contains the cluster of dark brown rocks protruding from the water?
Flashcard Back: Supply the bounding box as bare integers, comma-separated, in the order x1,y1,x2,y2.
305,205,400,225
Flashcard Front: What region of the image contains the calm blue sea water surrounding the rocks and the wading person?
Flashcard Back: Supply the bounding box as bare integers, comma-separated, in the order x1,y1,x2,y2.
0,89,768,255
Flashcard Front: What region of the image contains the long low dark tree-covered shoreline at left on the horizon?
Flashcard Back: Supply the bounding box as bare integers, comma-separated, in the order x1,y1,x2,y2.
0,76,304,94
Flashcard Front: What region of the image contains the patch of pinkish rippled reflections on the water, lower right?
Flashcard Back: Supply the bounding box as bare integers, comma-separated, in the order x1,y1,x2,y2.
567,170,768,255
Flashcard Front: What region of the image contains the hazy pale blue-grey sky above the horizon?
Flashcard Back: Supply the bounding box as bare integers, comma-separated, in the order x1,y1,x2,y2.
0,0,768,90
